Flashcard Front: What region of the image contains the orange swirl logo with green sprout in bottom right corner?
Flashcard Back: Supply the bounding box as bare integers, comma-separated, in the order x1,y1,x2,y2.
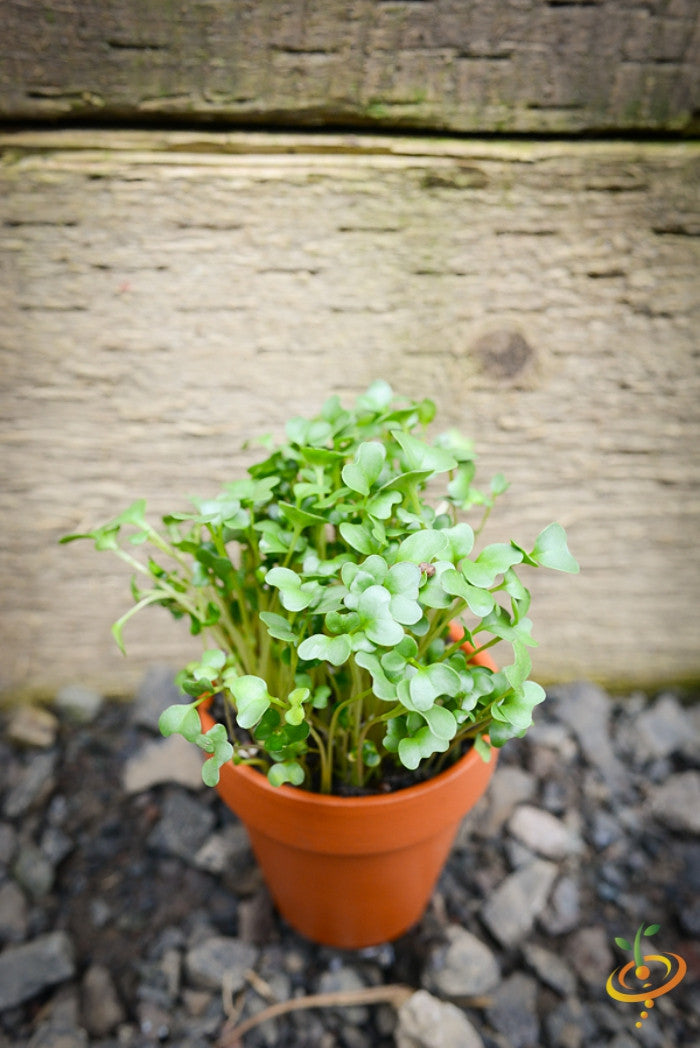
606,924,686,1029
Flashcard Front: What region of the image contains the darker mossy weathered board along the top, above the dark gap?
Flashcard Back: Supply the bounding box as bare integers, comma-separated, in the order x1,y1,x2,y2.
0,0,700,133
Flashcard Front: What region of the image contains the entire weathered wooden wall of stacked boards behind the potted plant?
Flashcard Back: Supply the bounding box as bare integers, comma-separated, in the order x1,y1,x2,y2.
0,6,700,697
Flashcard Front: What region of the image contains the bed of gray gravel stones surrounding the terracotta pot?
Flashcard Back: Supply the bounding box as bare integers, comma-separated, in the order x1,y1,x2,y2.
0,667,700,1048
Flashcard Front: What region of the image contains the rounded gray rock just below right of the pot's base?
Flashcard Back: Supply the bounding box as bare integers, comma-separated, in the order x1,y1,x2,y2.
422,925,501,998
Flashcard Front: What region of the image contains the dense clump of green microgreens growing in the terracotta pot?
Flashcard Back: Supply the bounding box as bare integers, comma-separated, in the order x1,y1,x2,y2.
62,381,578,793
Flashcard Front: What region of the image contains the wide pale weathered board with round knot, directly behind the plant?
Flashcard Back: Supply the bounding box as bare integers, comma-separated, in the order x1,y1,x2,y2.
0,132,700,695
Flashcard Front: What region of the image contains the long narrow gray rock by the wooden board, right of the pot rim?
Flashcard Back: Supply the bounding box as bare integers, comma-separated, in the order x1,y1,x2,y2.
552,681,626,789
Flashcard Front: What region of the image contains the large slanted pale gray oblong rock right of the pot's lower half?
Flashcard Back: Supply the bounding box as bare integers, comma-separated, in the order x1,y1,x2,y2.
481,859,557,946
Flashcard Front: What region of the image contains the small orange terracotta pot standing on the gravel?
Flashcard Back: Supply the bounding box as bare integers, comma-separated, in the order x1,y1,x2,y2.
200,641,496,948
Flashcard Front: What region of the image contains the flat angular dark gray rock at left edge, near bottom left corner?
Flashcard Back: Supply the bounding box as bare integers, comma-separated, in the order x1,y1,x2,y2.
0,932,75,1011
